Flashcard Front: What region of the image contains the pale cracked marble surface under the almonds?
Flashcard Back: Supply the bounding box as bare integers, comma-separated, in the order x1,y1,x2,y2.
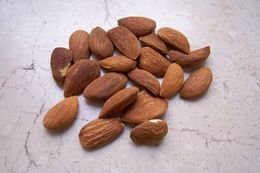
0,0,260,173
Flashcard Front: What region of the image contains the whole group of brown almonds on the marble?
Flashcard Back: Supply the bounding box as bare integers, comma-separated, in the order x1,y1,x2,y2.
43,17,212,149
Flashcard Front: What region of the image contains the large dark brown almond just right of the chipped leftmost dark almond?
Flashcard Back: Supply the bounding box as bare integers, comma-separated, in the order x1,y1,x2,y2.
64,59,100,97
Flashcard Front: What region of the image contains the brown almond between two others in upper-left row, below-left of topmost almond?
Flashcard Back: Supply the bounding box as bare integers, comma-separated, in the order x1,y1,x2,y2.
89,27,114,58
